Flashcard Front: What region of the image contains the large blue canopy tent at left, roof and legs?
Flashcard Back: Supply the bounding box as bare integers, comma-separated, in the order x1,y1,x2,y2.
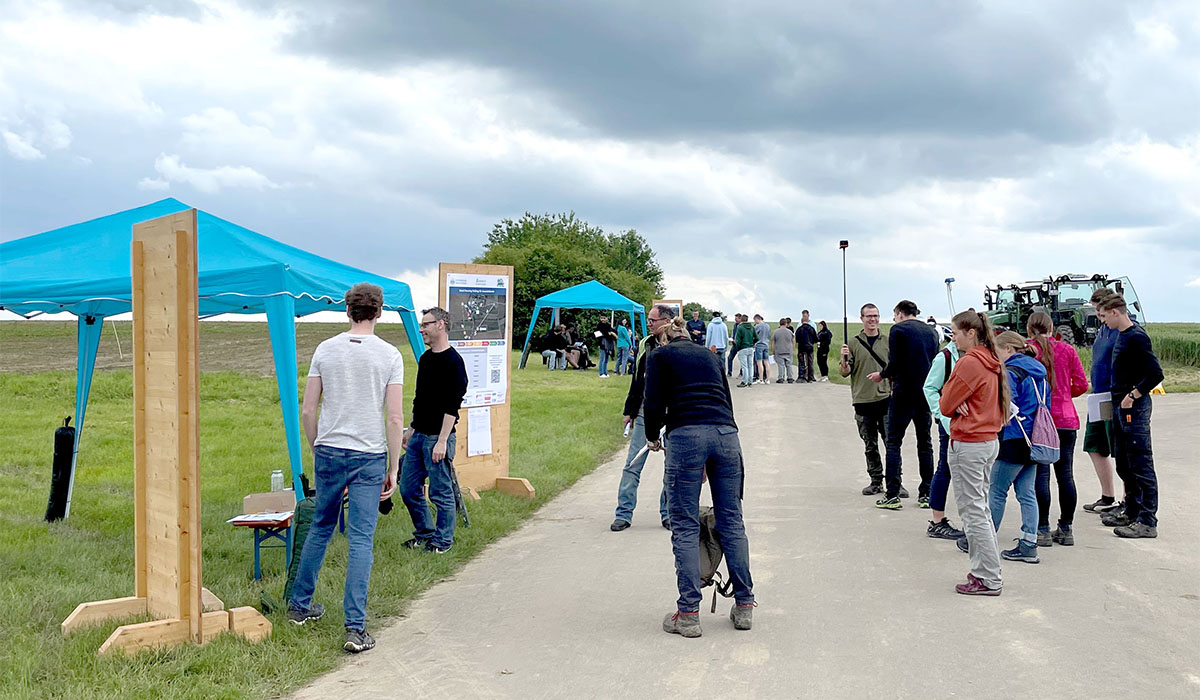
0,199,425,514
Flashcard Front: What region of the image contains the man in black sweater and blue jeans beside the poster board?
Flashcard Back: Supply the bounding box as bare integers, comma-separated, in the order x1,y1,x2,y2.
400,306,467,555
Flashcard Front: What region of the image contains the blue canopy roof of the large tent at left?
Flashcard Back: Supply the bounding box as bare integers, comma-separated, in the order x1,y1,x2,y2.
0,198,413,316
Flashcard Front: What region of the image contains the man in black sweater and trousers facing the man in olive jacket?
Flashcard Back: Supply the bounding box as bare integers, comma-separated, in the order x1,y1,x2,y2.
869,299,940,510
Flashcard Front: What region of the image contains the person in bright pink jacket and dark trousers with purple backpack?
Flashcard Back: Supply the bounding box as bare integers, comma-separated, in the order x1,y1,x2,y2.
1026,311,1088,546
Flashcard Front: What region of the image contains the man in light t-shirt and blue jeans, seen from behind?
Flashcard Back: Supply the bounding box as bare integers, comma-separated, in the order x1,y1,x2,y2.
288,282,404,653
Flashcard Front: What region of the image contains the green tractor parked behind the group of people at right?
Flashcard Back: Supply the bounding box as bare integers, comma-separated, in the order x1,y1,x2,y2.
984,275,1145,346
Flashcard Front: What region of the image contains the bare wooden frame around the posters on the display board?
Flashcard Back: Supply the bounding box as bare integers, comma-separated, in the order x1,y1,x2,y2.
438,263,535,498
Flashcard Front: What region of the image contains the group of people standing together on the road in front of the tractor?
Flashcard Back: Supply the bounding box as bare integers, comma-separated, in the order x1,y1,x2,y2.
840,288,1163,596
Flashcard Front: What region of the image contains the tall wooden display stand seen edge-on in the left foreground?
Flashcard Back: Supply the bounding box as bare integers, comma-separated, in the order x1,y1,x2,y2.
62,209,271,653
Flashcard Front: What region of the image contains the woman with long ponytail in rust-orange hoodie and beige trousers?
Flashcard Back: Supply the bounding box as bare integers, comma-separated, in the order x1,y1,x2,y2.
938,309,1009,596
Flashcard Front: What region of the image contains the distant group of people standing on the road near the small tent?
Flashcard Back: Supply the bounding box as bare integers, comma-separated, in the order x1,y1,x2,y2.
688,309,833,388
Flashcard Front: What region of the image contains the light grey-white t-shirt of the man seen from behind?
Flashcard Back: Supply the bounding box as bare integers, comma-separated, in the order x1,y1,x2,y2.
308,333,404,454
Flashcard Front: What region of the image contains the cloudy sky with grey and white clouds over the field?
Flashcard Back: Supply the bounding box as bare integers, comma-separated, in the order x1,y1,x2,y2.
0,0,1200,321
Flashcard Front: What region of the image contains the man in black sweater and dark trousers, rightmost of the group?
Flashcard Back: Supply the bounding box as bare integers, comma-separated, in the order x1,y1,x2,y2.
1099,294,1163,538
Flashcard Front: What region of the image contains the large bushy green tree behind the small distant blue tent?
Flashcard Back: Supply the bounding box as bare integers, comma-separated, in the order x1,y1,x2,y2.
474,211,664,341
